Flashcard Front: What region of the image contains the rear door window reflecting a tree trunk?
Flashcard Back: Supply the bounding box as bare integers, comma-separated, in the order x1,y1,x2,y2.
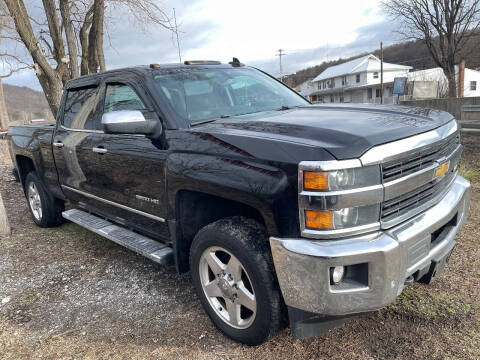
62,87,98,130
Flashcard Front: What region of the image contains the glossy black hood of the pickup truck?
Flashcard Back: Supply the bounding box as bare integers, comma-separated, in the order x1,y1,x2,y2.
192,105,453,160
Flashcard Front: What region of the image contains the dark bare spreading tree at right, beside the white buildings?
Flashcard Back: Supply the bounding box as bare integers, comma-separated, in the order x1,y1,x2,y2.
382,0,480,97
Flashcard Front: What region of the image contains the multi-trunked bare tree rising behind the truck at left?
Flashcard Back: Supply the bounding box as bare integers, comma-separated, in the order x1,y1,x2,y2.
0,0,173,116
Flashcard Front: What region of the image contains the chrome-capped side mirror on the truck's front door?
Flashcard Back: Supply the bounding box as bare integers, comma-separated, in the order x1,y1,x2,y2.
102,110,161,135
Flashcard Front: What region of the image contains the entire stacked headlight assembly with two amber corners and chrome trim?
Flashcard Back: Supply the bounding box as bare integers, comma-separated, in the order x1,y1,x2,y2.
299,160,383,239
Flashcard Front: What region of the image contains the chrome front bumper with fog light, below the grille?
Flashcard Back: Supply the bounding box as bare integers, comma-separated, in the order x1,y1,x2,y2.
270,176,471,315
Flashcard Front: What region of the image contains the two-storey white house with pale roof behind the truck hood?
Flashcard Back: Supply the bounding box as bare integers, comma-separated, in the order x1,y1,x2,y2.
310,55,411,103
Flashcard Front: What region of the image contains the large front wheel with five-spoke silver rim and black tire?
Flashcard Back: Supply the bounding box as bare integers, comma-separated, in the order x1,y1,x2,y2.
190,217,284,345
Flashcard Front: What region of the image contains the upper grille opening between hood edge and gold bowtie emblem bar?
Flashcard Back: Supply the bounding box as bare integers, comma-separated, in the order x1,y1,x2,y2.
382,133,460,182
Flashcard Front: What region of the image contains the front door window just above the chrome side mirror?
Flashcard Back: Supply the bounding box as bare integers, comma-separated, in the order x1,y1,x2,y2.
103,85,146,113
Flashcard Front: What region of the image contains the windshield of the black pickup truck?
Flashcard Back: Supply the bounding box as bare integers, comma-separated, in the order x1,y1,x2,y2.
155,68,308,123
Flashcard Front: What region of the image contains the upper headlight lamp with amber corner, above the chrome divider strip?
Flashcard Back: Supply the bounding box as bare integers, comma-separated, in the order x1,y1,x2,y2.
303,166,380,191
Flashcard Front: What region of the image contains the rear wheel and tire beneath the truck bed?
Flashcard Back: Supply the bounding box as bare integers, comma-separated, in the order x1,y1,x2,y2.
25,171,65,228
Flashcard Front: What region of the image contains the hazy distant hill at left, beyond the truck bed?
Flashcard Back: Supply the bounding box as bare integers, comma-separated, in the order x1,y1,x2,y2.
3,83,50,122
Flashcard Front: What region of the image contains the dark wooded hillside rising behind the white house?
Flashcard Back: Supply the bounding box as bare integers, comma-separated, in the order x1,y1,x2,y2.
284,41,480,87
